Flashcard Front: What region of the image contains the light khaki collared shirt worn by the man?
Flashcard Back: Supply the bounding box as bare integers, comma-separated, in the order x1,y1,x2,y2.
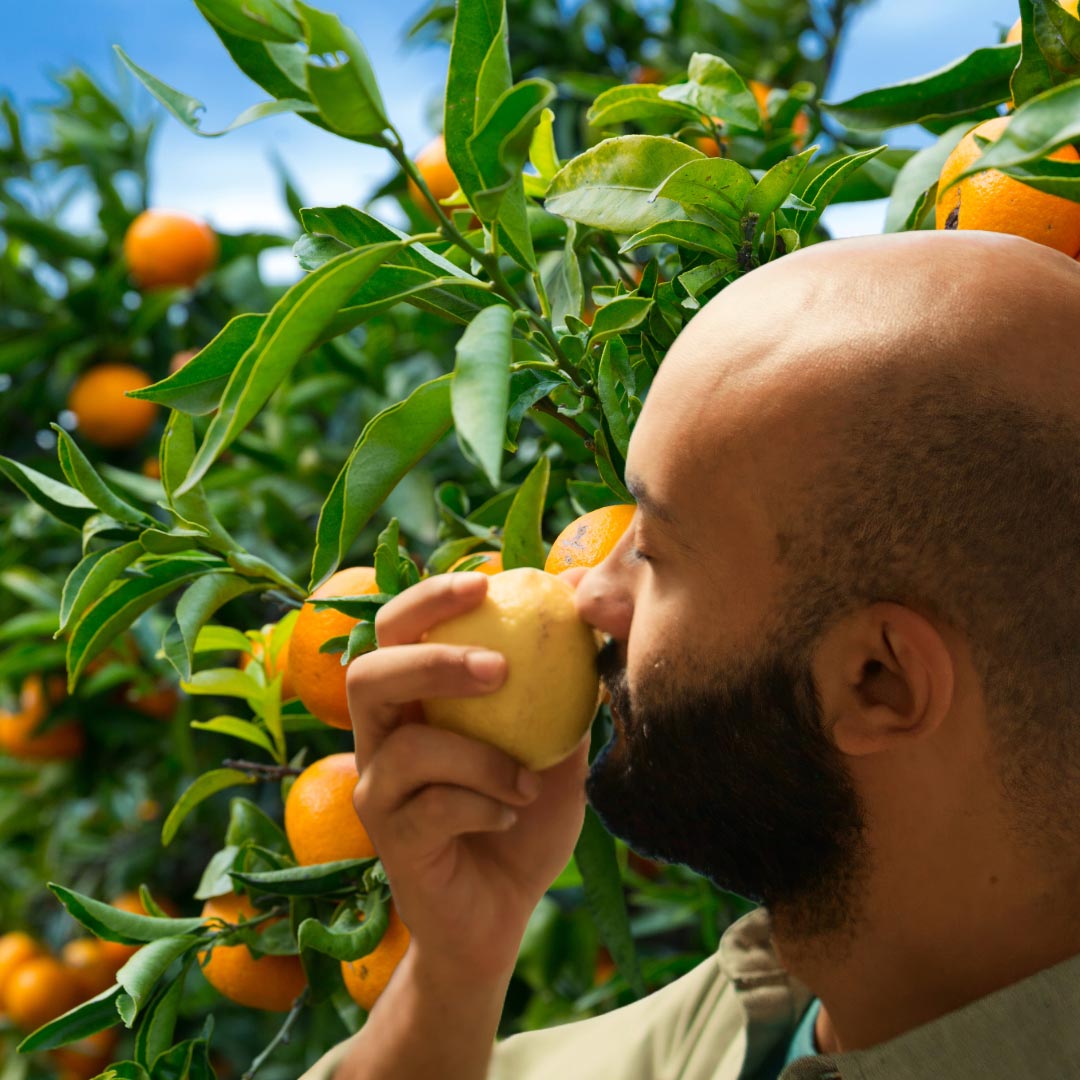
301,907,1080,1080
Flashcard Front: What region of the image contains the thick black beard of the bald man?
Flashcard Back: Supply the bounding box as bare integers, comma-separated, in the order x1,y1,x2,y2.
585,642,868,939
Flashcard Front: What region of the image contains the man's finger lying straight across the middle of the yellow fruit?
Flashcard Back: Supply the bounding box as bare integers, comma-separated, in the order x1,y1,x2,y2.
346,639,507,770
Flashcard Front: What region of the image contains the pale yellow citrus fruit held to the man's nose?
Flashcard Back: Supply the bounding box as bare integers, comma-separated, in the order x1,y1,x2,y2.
423,567,599,769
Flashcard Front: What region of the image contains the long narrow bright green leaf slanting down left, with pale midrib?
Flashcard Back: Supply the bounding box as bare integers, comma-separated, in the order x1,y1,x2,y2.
176,241,401,495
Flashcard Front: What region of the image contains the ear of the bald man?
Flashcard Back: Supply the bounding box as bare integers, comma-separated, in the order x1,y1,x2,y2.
812,603,956,757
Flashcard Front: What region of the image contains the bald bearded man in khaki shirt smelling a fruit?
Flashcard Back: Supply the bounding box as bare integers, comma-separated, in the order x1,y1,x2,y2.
298,233,1080,1080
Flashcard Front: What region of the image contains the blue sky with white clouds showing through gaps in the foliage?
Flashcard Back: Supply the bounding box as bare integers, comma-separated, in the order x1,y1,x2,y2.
8,0,1017,280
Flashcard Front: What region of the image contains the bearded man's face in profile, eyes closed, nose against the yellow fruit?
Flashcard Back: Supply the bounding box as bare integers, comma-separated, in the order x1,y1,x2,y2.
578,349,864,934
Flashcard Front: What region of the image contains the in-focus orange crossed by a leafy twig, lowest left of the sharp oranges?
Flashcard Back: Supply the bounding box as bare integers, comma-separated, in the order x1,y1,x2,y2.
199,892,307,1012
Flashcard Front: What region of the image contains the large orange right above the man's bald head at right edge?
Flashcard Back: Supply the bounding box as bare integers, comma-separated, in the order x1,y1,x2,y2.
936,117,1080,255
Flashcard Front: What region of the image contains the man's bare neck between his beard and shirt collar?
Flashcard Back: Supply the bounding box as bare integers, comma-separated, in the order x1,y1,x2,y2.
771,867,1080,1054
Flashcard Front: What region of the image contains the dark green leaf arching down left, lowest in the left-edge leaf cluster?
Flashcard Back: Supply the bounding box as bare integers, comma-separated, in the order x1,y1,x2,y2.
67,558,215,691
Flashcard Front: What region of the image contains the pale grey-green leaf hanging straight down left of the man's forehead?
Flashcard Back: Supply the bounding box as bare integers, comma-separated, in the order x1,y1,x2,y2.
450,307,514,487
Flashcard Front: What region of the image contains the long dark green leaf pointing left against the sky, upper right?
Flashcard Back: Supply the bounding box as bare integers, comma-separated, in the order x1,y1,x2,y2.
821,44,1020,131
